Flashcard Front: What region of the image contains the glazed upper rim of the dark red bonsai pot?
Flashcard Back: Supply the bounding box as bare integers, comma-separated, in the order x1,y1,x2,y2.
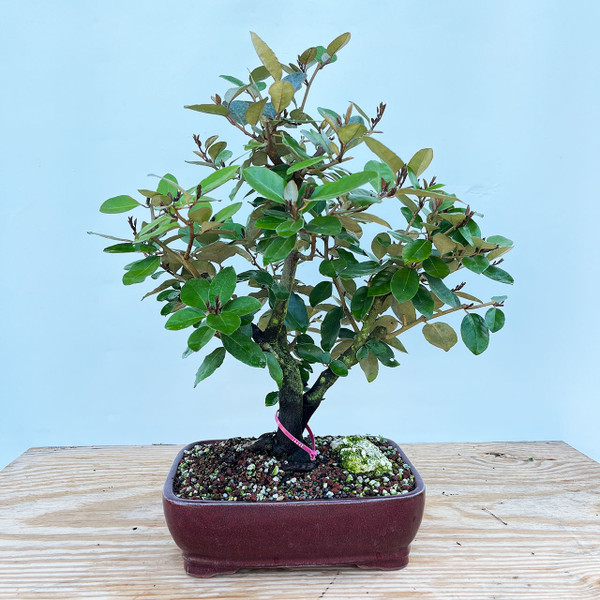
163,438,425,510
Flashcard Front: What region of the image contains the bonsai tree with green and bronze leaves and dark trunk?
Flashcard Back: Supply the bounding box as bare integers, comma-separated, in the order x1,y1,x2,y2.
92,33,513,467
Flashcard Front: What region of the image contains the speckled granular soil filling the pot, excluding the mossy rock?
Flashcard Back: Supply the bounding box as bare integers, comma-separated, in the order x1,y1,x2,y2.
173,436,415,502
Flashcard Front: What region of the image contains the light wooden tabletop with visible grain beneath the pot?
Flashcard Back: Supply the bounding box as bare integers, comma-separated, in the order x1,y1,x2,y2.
0,442,600,600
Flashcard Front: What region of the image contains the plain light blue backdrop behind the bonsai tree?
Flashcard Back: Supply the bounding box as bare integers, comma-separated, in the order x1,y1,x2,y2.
0,0,600,466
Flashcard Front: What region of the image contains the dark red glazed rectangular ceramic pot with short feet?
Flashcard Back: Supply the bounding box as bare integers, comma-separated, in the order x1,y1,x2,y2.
163,440,425,577
